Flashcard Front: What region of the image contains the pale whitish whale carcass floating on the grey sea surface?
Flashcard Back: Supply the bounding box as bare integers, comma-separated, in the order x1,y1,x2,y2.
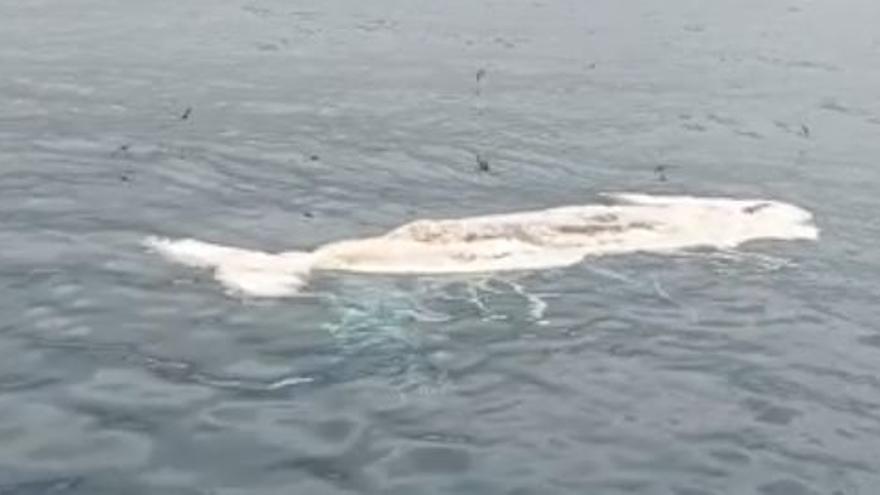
146,194,819,297
